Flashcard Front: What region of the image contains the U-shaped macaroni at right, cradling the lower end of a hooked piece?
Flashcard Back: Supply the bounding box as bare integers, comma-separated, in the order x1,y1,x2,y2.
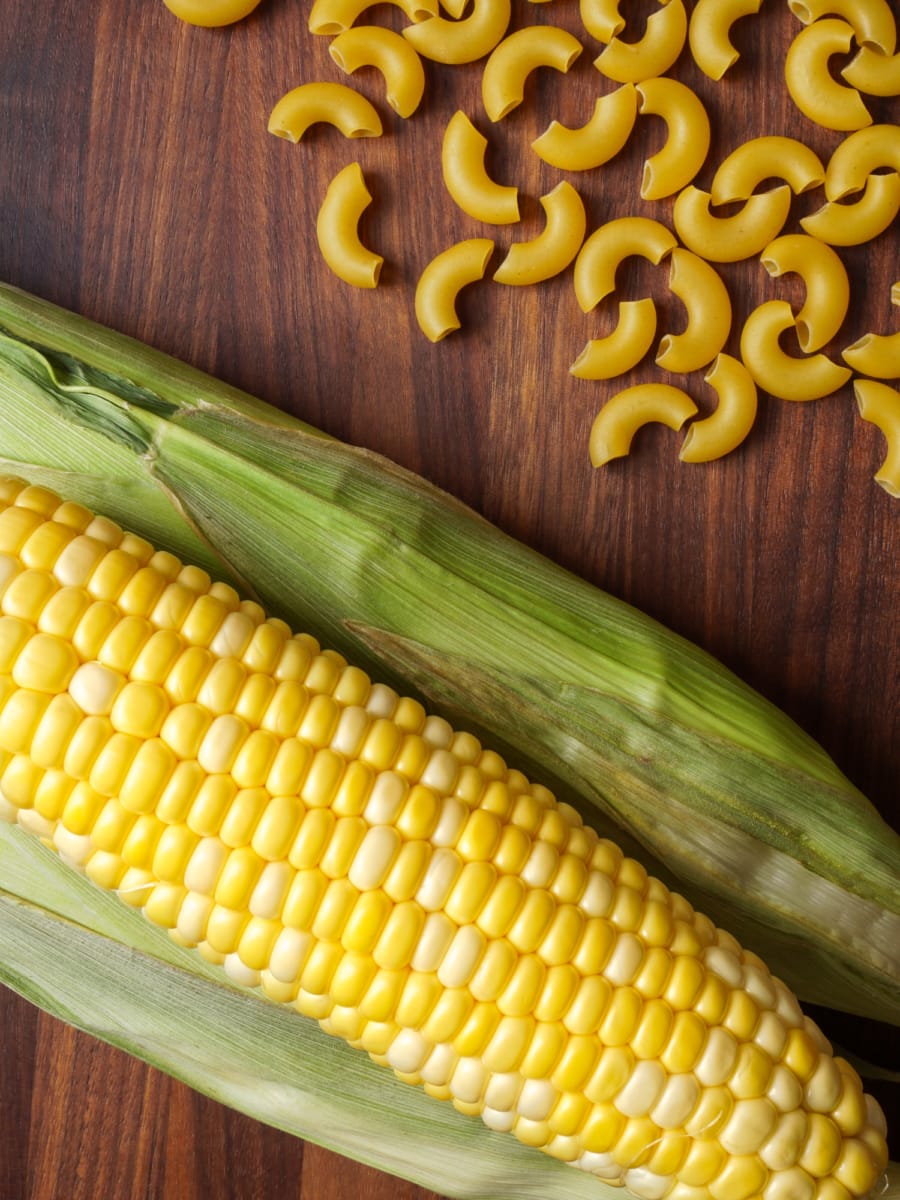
740,300,852,401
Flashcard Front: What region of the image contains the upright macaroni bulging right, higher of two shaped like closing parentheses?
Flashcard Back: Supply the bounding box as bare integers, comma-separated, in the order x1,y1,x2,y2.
637,78,709,200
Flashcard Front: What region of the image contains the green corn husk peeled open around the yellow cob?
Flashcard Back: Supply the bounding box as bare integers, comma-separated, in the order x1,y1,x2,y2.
0,286,900,1200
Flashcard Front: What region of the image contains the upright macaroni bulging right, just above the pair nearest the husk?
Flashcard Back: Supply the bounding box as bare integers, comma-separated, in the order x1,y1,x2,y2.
656,246,731,374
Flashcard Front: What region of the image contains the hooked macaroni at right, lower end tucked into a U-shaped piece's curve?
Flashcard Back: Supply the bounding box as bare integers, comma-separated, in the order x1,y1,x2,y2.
760,233,850,354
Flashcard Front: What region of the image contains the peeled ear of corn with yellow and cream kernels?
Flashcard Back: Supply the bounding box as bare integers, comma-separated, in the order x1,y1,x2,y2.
0,480,887,1200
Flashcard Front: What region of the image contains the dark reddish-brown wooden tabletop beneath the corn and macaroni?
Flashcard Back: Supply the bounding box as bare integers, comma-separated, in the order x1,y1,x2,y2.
0,0,900,1200
